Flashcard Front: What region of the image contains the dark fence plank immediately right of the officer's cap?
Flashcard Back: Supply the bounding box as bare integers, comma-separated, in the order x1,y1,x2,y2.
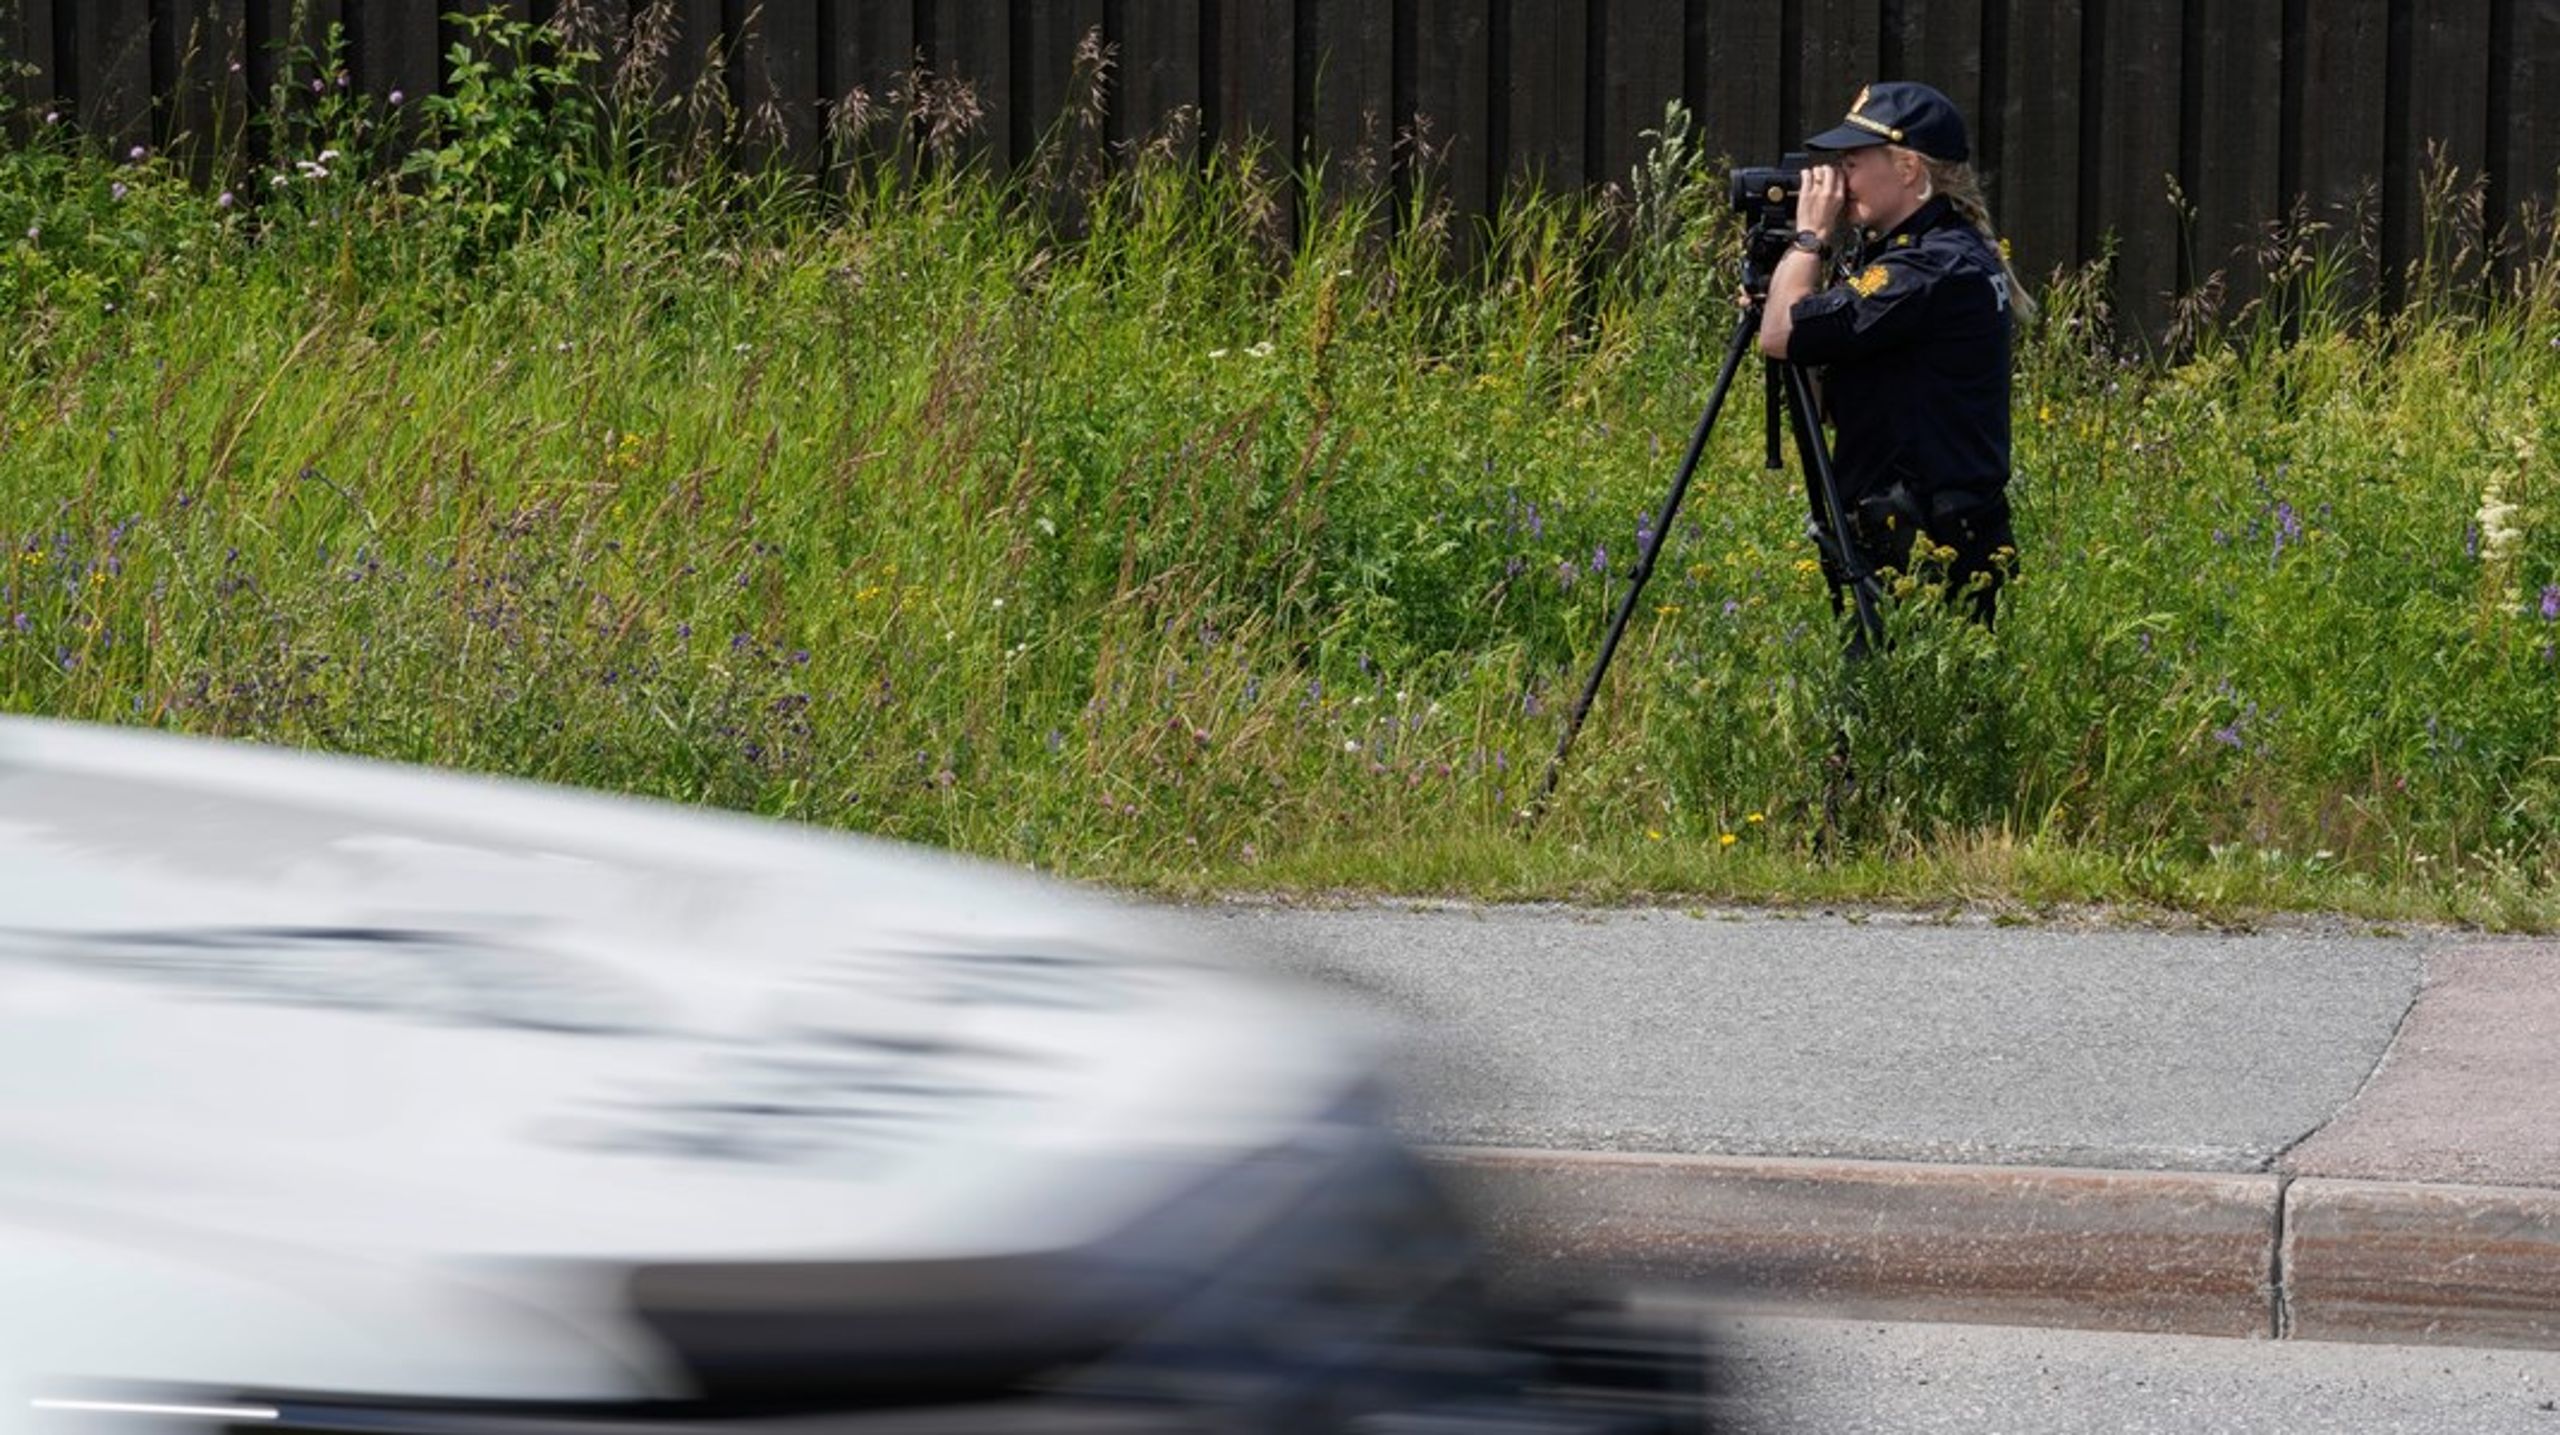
1992,0,2081,284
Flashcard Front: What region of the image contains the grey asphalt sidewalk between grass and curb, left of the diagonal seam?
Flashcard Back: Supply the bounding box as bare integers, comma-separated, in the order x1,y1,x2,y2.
1175,908,2416,1171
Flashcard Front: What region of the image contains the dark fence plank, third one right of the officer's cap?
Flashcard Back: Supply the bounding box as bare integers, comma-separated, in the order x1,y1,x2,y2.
2181,0,2286,312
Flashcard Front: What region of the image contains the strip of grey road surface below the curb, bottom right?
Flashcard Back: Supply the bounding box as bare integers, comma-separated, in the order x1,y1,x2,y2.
1715,1320,2560,1435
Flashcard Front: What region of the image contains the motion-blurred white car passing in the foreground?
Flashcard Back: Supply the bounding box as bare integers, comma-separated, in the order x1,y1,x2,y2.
0,719,1702,1435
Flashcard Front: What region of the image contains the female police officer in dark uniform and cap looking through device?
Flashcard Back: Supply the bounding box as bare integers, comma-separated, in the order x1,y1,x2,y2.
1759,82,2033,627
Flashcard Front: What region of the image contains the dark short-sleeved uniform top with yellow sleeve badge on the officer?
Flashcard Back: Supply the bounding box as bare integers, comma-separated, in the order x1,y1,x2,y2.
1787,197,2010,512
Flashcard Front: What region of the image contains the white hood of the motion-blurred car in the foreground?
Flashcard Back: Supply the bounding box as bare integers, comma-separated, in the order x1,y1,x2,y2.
0,721,1377,1401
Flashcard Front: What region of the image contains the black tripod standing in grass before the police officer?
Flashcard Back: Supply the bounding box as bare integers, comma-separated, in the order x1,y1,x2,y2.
1539,291,1884,808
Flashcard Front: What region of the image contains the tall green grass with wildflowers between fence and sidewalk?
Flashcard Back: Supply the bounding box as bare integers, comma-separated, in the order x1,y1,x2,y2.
0,16,2560,923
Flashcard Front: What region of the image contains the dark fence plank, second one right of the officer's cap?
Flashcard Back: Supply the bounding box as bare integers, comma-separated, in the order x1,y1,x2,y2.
2084,0,2181,333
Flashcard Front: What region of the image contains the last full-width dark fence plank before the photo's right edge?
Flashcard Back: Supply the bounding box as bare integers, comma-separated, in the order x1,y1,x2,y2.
2383,0,2499,287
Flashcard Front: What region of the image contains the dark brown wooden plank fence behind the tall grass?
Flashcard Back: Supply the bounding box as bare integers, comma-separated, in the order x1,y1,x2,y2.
0,0,2560,335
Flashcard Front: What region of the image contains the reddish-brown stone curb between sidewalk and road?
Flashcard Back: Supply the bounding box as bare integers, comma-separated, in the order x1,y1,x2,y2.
1431,1146,2560,1348
